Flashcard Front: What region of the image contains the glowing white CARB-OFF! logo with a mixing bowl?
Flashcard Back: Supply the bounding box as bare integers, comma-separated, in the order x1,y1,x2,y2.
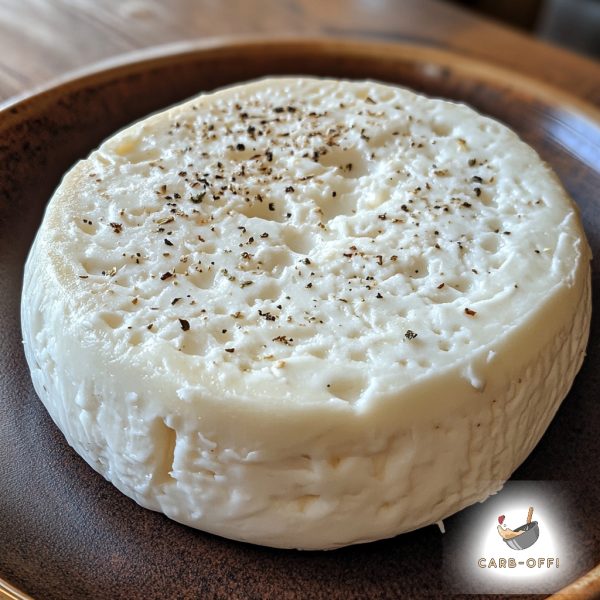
443,481,593,594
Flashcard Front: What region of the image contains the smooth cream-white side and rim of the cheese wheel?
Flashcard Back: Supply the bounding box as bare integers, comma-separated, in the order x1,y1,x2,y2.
22,80,591,548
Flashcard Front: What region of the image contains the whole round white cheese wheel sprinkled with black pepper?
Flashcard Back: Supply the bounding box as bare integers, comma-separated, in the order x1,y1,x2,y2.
22,78,590,549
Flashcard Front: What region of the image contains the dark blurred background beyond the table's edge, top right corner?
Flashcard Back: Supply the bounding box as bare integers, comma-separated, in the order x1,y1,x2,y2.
448,0,600,59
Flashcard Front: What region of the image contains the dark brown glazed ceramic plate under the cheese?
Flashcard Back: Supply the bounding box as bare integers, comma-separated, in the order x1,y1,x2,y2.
0,40,600,599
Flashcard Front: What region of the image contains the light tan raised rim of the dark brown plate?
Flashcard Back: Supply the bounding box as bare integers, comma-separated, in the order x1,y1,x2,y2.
0,34,600,600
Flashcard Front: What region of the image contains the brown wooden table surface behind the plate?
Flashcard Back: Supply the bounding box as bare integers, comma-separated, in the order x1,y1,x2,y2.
0,0,600,105
